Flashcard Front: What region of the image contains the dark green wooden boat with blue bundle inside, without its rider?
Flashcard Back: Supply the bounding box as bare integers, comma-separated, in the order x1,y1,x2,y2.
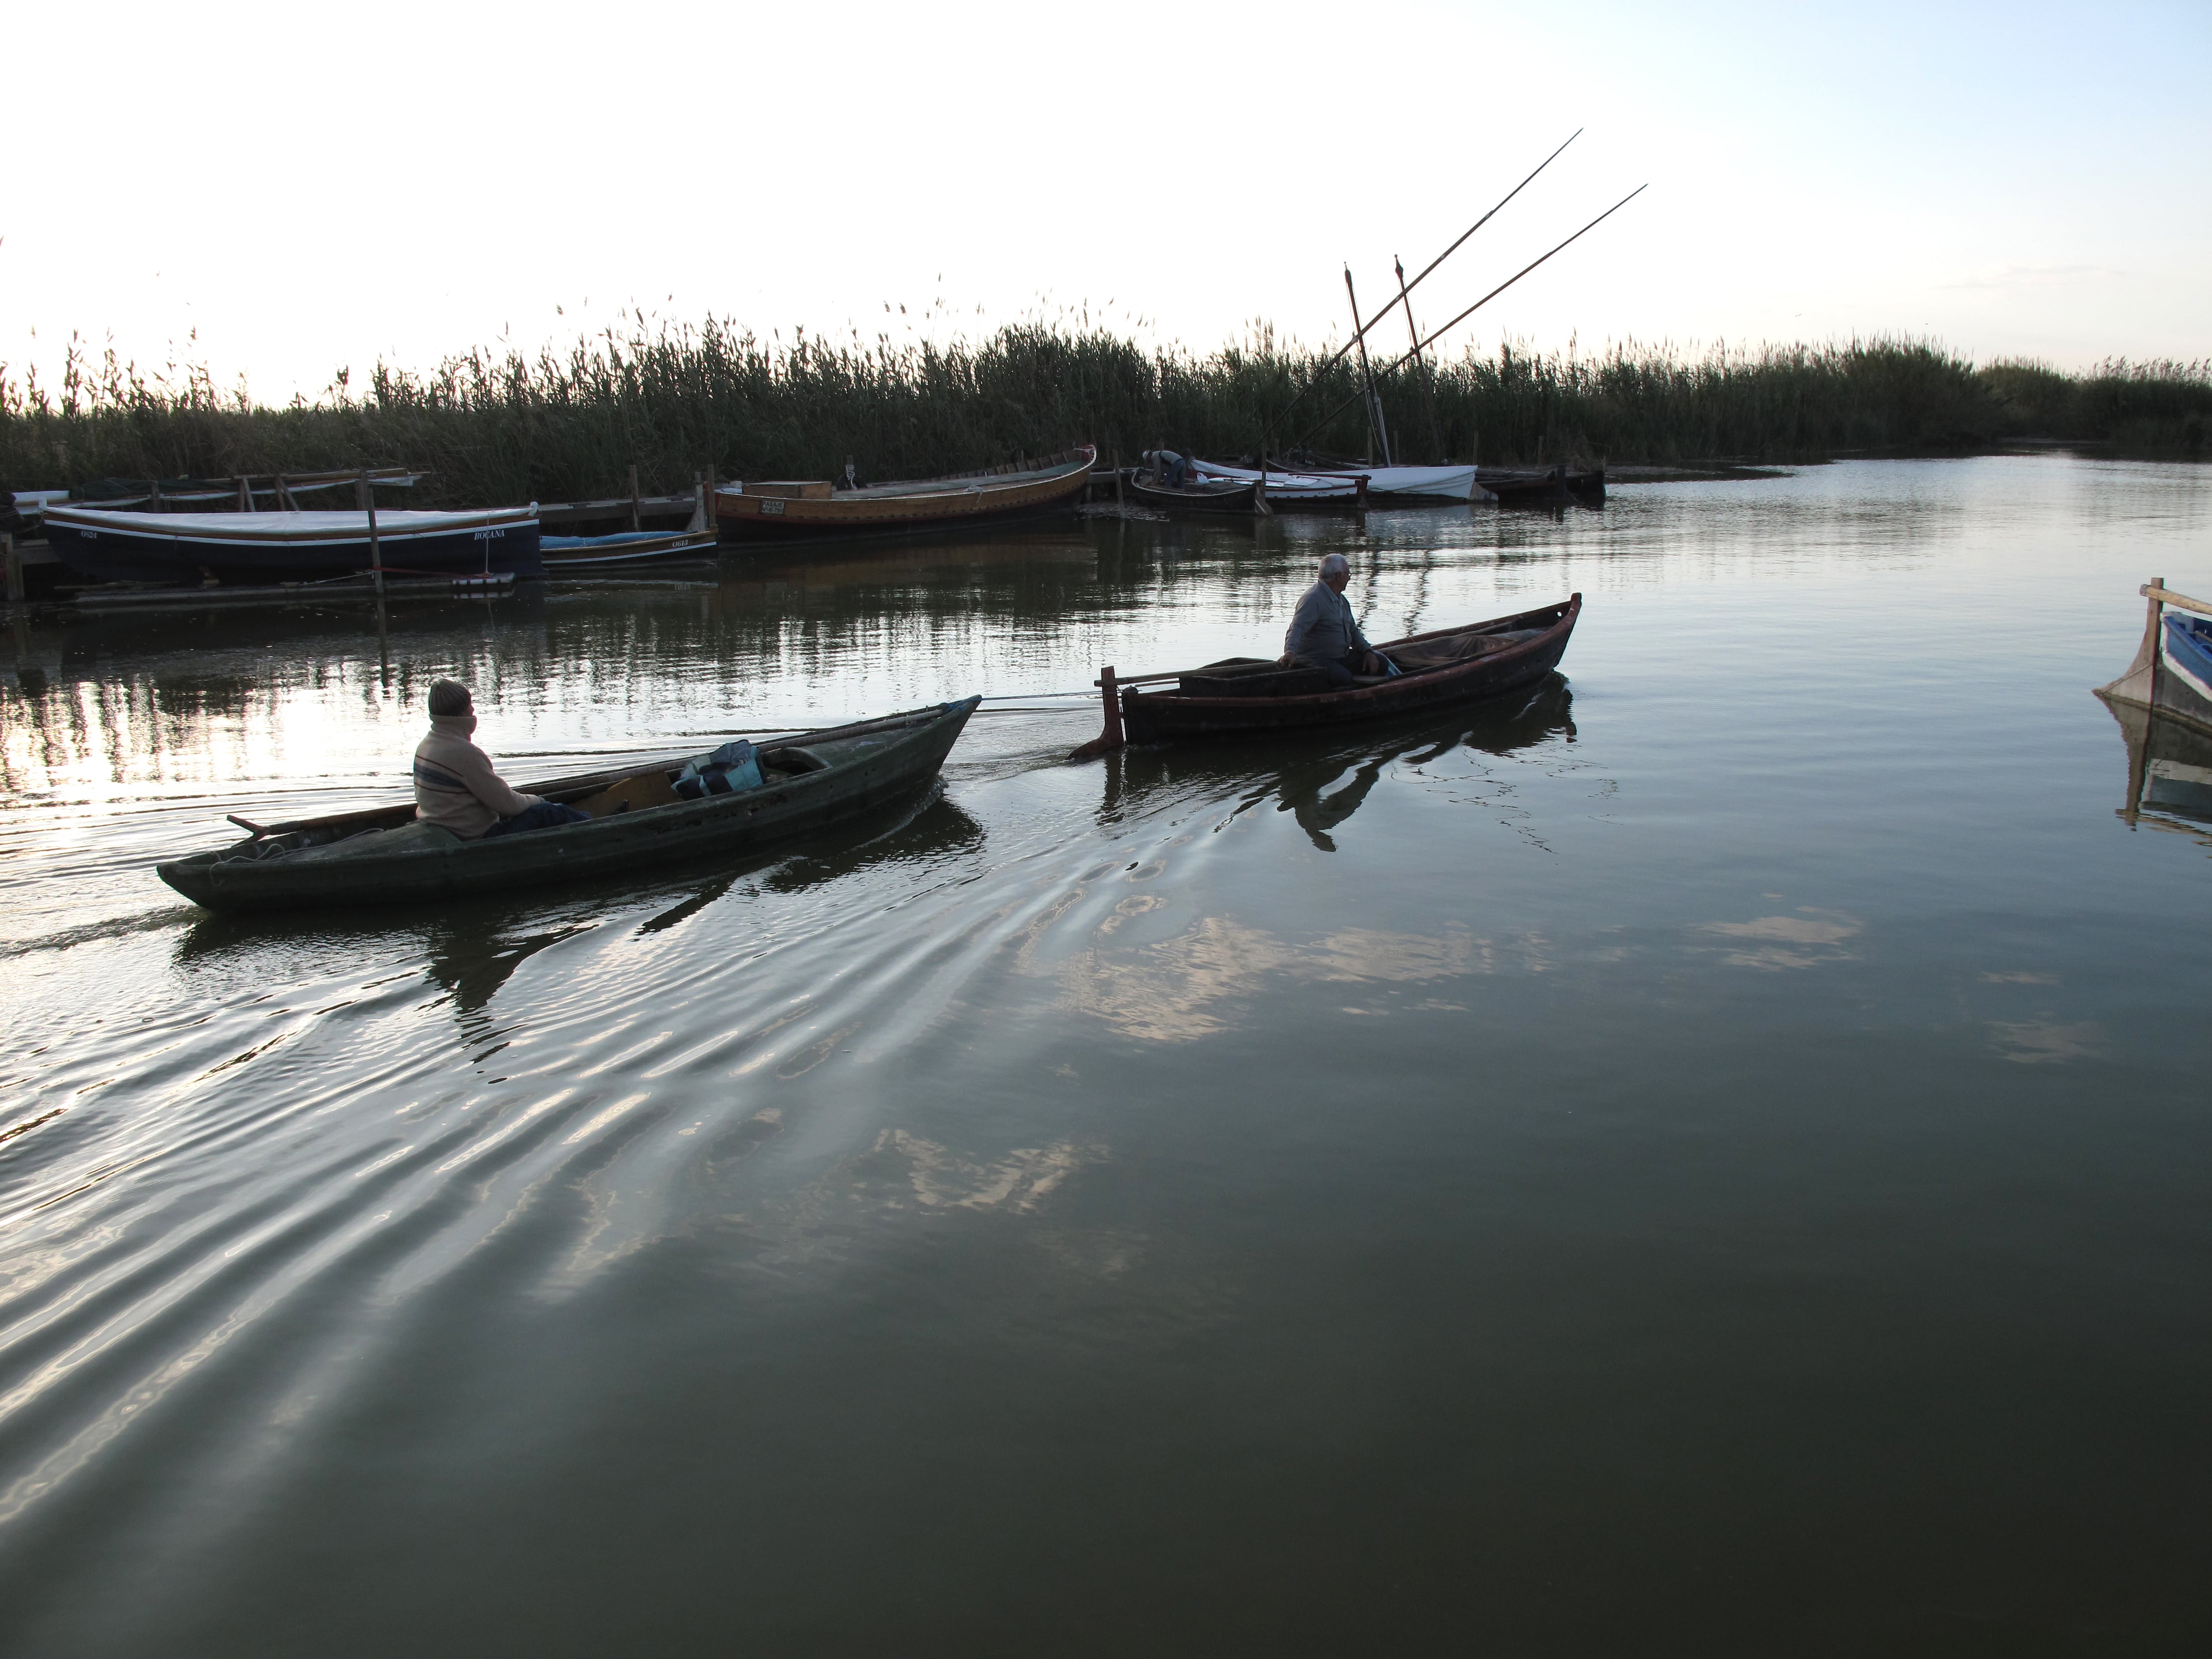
155,697,982,911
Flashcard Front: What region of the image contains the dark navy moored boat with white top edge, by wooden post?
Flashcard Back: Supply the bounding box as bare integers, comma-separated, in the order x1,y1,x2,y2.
47,502,544,584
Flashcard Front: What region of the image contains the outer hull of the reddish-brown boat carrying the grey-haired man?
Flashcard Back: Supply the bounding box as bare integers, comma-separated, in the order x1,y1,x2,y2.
1122,593,1581,743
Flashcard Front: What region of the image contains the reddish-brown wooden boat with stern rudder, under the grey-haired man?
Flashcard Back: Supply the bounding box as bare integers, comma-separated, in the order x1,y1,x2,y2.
1077,593,1581,754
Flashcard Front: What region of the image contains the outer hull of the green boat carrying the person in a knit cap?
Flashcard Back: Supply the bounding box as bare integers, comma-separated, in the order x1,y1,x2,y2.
157,697,980,911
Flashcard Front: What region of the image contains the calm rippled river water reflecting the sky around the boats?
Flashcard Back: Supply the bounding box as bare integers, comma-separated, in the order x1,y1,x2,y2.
0,458,2212,1654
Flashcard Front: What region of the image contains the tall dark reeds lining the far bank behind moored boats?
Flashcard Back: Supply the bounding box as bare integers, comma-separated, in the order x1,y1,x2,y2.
0,316,2212,506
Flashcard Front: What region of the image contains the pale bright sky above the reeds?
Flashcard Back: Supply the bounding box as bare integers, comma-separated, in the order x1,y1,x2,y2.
0,0,2212,403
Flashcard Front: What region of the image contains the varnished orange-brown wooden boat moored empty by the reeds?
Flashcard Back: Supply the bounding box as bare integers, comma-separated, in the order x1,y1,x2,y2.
714,445,1097,542
